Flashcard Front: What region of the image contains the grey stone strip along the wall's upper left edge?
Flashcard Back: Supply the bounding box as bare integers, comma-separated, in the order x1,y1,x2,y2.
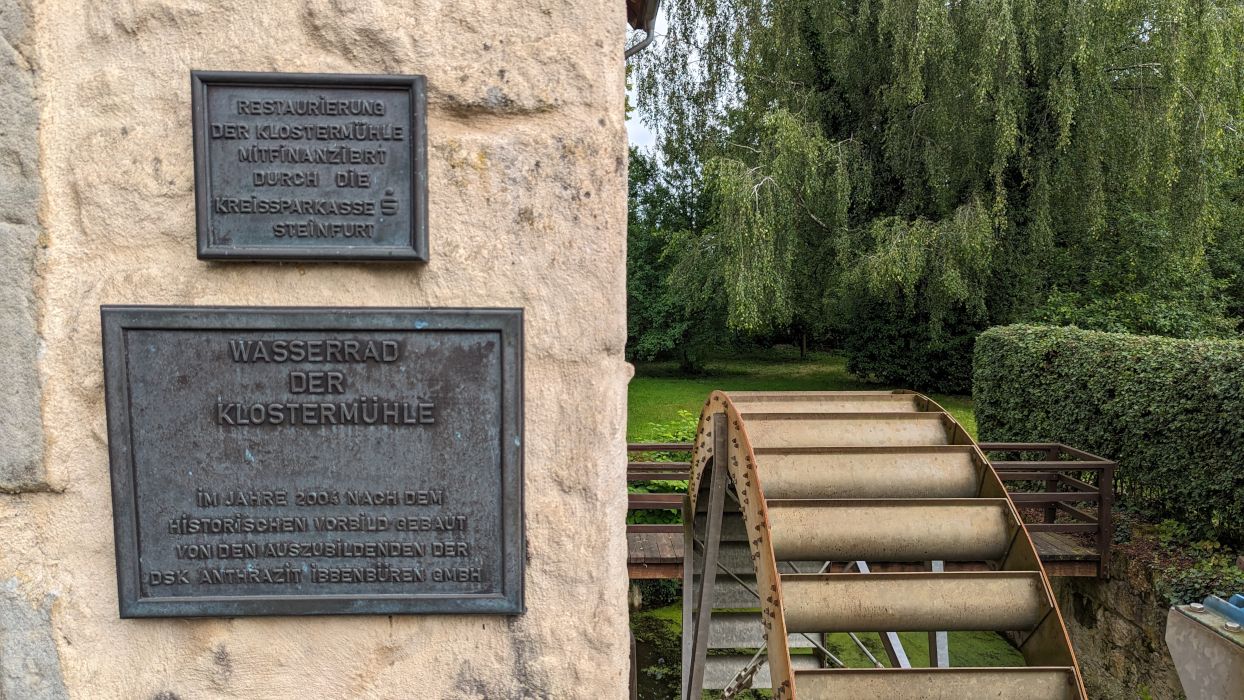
0,0,46,491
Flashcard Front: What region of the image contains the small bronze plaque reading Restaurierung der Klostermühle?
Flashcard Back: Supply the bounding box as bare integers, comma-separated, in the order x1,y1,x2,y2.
190,71,428,261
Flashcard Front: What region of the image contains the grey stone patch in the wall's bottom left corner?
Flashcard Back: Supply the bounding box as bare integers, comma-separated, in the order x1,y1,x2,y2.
0,579,67,700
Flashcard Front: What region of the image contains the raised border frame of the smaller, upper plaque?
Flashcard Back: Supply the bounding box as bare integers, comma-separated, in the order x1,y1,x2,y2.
190,71,428,262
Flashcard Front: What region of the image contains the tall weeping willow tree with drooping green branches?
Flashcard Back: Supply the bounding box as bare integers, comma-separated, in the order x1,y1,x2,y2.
637,0,1244,389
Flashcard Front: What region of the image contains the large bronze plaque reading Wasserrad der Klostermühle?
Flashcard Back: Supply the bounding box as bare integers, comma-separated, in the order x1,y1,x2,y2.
102,306,524,618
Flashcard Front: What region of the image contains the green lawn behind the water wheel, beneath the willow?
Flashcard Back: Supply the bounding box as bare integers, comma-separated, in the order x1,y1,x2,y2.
627,352,977,441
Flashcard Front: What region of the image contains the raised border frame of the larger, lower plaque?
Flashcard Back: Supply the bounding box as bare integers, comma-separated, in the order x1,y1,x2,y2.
100,305,526,618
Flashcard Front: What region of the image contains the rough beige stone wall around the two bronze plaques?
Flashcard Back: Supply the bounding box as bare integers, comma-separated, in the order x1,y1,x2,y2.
0,0,629,700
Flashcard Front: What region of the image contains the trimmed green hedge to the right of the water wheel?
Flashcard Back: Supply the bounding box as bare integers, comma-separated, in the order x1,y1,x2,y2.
973,326,1244,545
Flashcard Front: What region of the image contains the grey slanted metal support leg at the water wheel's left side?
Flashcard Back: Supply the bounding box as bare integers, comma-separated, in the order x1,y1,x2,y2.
683,413,729,700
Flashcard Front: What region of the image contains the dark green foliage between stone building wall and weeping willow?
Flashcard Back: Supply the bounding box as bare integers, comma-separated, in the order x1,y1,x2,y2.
627,149,725,369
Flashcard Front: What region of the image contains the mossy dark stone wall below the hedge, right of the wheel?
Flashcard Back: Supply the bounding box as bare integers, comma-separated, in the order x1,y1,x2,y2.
1051,548,1184,700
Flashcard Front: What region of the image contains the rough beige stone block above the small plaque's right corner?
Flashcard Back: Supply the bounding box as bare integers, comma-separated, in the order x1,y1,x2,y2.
301,0,602,117
